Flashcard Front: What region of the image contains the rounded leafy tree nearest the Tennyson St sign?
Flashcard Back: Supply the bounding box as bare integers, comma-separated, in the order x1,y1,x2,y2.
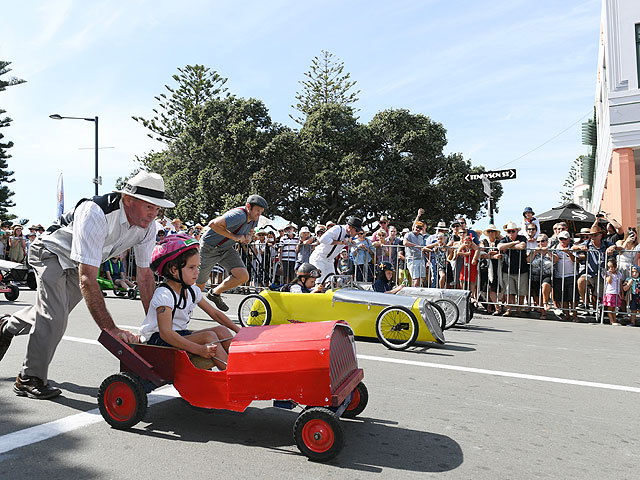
364,109,502,231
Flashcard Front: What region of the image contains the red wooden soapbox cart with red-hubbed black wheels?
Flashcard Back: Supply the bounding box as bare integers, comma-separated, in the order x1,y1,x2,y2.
98,320,369,461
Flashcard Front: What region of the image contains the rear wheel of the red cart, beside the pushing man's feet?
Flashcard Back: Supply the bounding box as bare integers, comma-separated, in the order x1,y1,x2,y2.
98,372,147,430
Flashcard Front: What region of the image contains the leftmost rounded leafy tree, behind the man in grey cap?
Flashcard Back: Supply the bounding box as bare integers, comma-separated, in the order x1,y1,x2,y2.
140,97,280,221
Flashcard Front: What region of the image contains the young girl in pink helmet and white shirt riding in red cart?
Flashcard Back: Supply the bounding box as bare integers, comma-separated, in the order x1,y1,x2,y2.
140,234,240,370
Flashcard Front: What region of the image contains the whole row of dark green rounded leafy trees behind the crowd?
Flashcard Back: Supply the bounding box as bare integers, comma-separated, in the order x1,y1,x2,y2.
138,62,502,231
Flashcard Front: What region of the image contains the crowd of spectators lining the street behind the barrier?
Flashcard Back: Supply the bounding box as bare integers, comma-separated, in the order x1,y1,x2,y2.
7,207,640,324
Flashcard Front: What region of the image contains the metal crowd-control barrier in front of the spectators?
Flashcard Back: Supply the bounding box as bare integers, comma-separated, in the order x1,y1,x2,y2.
198,240,640,323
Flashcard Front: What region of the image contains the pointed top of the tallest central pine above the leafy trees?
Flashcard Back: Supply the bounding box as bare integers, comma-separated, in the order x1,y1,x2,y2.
289,50,360,125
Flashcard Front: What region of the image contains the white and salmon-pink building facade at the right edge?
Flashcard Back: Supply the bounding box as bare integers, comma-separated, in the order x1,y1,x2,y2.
575,0,640,229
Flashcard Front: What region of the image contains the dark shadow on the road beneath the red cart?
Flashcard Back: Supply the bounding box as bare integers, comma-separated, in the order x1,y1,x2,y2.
136,399,463,472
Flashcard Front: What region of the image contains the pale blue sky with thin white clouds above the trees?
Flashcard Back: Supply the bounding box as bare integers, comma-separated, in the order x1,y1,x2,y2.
0,0,601,231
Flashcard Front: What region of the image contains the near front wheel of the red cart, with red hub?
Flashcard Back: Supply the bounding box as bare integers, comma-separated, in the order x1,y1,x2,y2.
293,407,344,462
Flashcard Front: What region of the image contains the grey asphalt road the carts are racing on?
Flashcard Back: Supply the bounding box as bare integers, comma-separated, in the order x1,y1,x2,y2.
0,290,640,480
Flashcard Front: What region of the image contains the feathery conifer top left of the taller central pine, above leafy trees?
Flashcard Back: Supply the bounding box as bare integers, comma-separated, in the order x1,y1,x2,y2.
131,64,227,143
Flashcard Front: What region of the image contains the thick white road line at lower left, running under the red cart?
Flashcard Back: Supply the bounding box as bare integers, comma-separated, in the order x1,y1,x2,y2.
0,386,180,454
